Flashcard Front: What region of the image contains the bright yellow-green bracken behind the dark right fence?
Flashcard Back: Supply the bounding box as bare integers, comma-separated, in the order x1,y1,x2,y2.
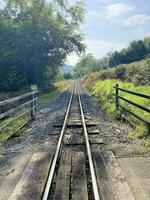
84,78,150,137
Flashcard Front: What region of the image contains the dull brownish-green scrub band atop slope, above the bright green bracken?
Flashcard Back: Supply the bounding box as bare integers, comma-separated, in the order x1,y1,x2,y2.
83,57,150,85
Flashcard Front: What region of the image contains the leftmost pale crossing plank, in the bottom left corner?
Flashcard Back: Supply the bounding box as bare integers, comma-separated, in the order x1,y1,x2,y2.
0,153,32,200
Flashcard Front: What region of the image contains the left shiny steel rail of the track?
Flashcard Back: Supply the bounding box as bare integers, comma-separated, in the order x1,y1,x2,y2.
42,86,74,200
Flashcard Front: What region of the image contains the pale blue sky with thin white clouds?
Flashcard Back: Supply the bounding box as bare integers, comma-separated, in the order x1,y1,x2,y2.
66,0,150,65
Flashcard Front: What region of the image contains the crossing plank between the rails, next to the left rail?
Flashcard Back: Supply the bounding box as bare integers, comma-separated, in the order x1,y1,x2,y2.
53,151,71,200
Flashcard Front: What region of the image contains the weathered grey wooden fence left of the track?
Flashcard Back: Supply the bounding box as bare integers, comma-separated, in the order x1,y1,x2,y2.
0,91,38,136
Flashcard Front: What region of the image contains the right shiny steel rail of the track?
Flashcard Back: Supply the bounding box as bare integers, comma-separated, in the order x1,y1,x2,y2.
78,83,100,200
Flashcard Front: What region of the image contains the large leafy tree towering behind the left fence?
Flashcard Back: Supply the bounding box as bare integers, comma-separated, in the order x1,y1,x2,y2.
0,0,85,91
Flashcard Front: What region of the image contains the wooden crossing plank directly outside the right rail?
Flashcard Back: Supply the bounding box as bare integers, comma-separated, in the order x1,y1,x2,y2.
92,150,119,200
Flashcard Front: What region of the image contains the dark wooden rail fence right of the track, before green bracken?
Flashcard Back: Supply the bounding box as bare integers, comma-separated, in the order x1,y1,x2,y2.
113,84,150,126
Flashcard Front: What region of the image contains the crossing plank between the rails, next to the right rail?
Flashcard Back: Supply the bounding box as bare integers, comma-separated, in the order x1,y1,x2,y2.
72,152,88,200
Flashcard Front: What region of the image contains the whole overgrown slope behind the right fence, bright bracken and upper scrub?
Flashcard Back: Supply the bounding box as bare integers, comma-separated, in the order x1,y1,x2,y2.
83,58,150,142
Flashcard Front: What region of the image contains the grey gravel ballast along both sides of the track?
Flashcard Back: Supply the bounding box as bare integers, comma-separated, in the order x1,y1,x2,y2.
4,83,139,154
